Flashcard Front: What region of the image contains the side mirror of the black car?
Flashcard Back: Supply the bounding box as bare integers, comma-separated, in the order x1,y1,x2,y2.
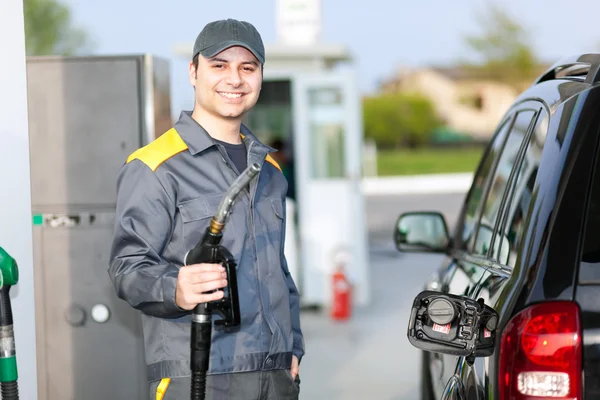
394,212,450,252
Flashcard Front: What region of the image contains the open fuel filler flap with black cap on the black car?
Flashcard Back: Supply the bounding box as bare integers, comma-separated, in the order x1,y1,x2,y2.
408,291,498,357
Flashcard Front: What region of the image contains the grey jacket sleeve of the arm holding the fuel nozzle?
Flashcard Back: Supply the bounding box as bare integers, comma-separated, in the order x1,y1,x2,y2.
108,160,186,318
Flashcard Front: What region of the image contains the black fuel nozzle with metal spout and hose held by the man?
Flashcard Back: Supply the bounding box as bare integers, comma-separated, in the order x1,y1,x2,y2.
185,163,261,400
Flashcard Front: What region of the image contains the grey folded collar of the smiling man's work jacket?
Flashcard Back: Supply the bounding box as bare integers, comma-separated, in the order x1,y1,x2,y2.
175,111,277,155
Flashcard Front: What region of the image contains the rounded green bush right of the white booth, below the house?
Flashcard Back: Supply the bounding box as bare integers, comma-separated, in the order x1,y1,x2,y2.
363,94,440,148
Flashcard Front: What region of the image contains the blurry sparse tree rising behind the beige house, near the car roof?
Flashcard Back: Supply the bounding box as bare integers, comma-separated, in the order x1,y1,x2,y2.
464,5,543,89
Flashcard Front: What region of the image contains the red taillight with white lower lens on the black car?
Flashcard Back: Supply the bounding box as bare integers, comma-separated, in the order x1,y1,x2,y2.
499,301,582,400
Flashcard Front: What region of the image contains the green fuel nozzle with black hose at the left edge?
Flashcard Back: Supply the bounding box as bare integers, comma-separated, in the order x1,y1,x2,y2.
0,247,19,400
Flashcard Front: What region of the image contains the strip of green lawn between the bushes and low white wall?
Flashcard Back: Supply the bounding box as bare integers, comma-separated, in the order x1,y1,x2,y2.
377,147,484,176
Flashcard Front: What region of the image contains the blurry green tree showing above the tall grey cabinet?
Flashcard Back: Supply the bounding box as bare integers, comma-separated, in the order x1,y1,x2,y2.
23,0,92,56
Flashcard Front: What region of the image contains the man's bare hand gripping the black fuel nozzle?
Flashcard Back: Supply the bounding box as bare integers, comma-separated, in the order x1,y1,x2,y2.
175,264,227,310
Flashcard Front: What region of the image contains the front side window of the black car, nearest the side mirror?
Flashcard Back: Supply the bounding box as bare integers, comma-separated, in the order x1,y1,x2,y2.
459,118,512,250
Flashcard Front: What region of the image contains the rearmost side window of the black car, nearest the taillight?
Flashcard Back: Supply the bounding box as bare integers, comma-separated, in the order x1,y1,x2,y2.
494,112,548,267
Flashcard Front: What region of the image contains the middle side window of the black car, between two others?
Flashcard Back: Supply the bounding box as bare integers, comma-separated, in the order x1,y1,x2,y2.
473,110,535,255
